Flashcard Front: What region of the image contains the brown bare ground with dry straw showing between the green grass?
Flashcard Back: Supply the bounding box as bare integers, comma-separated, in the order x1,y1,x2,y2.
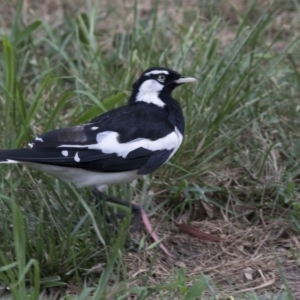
0,0,300,299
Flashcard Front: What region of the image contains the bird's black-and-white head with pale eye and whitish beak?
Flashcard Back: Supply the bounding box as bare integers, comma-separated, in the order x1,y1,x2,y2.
130,67,197,107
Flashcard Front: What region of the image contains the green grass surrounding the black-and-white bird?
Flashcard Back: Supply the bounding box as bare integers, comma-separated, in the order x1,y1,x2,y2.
0,1,300,300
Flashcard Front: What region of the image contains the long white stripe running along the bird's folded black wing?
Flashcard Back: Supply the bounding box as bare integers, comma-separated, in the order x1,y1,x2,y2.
58,127,183,161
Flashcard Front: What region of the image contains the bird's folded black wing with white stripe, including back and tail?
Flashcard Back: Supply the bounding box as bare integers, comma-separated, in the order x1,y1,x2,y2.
0,106,182,175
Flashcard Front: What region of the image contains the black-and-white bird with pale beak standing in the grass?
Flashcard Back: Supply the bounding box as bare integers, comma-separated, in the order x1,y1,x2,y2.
0,67,197,250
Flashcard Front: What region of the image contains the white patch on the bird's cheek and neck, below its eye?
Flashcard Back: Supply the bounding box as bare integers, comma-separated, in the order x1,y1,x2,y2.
135,79,166,107
